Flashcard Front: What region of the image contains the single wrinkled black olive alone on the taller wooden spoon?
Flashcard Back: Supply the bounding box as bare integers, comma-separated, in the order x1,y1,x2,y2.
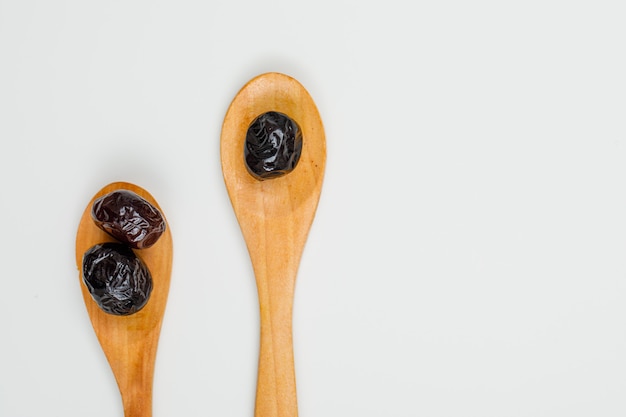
244,111,302,180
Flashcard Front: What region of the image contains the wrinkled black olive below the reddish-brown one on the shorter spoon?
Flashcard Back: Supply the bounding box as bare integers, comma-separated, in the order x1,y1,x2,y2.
83,242,152,316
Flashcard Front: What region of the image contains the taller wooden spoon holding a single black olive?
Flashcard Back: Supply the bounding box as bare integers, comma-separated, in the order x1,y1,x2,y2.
221,73,326,417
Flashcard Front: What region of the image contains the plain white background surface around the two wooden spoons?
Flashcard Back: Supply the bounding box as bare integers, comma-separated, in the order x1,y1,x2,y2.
0,0,626,417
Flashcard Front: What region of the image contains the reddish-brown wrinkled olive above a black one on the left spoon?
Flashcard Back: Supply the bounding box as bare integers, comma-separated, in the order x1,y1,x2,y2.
91,190,165,249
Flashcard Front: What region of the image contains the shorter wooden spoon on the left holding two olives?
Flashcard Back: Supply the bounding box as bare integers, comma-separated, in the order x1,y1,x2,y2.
76,182,172,417
